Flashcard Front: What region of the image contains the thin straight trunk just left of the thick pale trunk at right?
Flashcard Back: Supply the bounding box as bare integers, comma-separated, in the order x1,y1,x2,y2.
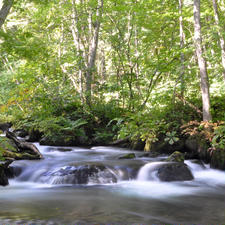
179,0,185,97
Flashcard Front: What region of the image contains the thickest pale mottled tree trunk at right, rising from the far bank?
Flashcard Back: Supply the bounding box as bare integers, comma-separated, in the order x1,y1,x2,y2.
194,0,212,121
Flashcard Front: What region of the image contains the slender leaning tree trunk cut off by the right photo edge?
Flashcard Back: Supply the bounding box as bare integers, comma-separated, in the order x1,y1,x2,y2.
212,0,225,82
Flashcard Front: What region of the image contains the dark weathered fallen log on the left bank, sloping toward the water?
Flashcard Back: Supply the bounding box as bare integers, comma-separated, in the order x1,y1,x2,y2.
6,130,43,159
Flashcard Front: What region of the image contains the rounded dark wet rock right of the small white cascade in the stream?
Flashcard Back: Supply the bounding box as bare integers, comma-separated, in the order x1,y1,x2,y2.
156,162,194,181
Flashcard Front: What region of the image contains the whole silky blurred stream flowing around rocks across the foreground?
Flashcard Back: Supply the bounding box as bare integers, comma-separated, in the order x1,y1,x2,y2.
0,144,225,225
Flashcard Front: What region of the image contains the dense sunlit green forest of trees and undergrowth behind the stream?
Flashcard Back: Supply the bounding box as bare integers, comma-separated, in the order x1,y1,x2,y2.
0,0,225,162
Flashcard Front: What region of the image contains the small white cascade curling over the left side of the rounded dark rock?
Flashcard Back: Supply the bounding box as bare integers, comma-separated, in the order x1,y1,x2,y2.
137,162,166,181
